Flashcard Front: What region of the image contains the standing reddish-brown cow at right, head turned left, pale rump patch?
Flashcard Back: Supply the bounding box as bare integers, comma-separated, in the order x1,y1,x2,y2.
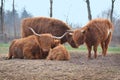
68,18,113,58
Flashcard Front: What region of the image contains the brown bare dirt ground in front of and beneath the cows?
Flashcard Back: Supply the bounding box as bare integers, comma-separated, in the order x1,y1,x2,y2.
0,52,120,80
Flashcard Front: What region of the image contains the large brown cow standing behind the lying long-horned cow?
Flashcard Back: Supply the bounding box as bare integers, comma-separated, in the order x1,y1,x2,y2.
21,17,77,48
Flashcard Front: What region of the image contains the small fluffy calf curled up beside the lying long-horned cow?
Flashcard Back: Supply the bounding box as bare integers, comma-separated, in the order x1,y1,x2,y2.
47,44,70,60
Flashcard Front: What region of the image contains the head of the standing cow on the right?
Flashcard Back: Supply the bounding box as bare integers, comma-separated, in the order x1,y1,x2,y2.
68,29,86,47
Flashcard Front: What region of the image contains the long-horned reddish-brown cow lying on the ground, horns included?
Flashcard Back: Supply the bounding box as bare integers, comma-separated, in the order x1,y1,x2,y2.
8,28,66,59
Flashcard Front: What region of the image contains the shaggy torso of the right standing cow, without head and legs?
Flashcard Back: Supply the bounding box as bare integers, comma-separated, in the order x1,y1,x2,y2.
86,19,113,45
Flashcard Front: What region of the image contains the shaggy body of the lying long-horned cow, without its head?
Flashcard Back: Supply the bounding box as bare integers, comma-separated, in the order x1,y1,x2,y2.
8,35,42,59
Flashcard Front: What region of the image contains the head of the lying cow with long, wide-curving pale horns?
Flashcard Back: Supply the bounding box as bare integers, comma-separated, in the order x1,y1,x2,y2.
30,28,66,52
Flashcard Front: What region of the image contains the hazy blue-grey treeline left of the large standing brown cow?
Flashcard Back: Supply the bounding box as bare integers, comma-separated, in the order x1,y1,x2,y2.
0,8,32,42
